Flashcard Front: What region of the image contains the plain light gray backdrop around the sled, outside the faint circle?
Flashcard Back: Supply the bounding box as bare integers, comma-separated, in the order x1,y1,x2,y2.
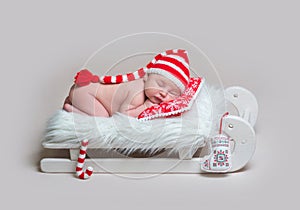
0,0,300,209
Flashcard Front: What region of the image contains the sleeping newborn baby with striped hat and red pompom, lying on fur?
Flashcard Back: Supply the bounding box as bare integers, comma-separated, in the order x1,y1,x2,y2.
63,49,190,117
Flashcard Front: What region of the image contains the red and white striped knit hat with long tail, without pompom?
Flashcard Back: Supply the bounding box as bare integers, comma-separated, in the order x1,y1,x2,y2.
100,49,190,92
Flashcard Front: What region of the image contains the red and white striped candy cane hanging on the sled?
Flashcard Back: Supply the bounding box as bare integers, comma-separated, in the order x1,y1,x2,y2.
76,139,93,179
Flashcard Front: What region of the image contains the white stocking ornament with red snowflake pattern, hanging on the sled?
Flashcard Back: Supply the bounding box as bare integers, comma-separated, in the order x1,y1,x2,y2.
201,134,232,173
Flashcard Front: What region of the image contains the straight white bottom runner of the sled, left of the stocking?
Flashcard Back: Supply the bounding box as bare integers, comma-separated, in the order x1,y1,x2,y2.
41,158,201,174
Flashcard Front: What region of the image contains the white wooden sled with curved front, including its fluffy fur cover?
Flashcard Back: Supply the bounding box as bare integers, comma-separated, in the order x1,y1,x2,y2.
40,85,258,174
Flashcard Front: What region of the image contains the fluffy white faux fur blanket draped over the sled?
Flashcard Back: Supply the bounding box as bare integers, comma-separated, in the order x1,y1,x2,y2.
42,84,225,154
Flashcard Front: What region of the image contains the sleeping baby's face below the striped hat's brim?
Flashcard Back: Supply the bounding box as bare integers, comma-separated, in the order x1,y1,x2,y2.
145,74,181,104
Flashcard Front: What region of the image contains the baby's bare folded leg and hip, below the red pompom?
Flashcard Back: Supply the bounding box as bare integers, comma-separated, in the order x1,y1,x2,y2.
64,83,109,117
